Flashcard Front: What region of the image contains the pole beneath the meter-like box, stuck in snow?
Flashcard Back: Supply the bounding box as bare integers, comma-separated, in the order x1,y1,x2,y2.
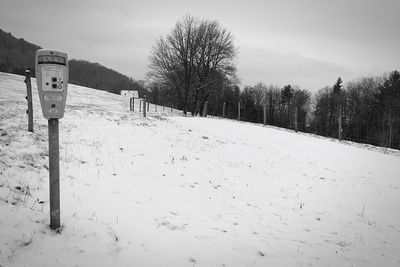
48,119,61,230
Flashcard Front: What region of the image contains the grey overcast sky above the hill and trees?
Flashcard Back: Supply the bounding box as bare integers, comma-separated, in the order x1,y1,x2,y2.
0,0,400,91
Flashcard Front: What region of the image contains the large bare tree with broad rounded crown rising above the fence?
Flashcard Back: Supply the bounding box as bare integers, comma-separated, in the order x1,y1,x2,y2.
148,15,236,114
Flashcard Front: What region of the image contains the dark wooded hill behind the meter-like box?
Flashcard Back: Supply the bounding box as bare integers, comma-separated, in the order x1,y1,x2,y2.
0,29,145,96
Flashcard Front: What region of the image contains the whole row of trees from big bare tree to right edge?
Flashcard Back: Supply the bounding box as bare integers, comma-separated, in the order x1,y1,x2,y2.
146,15,400,149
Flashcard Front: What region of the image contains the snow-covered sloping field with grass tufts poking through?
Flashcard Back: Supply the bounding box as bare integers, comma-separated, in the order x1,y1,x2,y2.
0,73,400,267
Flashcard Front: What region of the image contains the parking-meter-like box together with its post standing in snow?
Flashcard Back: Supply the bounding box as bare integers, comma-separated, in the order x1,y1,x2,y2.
35,49,68,230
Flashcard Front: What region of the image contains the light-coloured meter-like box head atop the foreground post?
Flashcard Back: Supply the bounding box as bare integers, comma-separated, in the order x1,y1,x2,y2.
35,49,68,119
